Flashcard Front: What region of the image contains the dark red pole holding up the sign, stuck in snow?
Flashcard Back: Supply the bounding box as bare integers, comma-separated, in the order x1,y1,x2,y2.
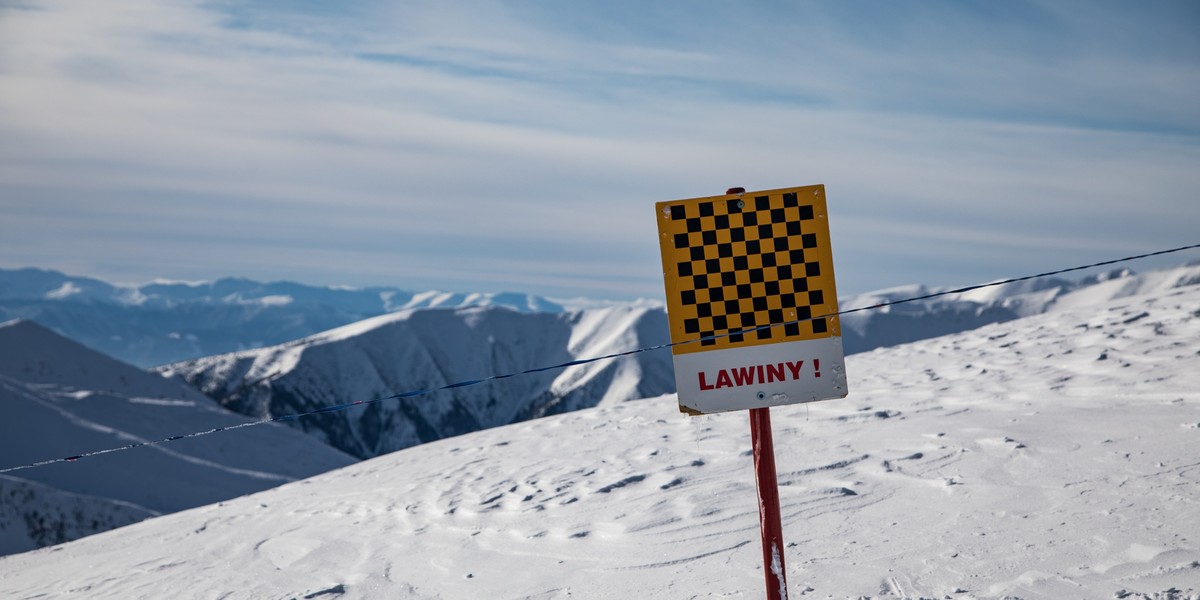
750,408,787,600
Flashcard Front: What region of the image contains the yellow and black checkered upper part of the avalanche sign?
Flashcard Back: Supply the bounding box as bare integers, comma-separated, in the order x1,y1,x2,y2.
655,186,841,354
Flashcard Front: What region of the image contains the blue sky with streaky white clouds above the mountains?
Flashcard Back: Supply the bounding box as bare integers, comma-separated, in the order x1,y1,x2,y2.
0,0,1200,299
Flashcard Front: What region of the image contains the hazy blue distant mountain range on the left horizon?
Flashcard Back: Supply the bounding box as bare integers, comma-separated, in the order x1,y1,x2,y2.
0,269,563,367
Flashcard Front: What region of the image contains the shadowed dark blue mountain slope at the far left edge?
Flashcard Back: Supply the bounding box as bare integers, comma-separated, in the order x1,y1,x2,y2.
0,322,354,552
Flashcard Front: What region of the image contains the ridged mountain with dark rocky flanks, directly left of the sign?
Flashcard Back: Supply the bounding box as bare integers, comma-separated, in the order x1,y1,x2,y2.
157,306,674,458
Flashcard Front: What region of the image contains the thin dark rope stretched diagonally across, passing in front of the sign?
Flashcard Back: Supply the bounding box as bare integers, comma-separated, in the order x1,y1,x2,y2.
0,244,1200,474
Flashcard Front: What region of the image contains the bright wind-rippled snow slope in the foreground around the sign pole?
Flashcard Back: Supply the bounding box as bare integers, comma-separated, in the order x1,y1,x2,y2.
0,286,1200,600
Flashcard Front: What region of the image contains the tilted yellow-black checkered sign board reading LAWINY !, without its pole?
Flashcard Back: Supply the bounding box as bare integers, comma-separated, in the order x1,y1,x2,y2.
655,185,847,414
